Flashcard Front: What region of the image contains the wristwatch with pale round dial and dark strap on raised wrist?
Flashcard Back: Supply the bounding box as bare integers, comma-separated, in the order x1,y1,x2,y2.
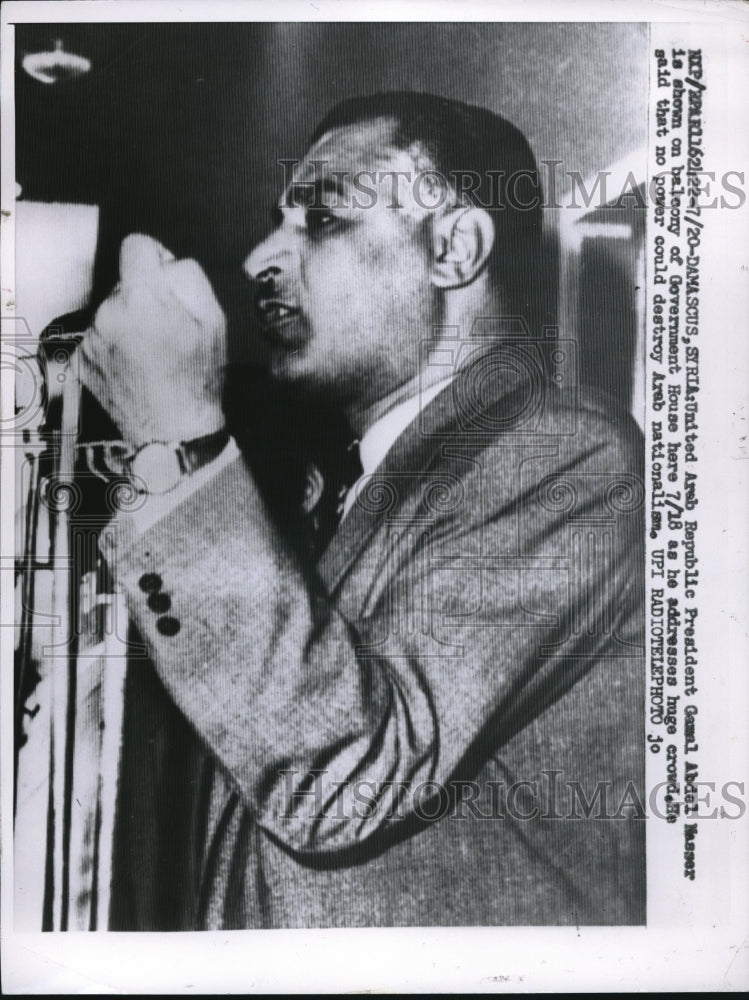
126,428,229,494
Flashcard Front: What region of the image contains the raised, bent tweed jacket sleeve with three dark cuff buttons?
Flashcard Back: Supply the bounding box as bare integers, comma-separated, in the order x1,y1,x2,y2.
106,410,642,854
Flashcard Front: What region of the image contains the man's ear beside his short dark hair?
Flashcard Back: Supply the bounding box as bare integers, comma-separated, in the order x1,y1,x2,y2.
431,207,494,288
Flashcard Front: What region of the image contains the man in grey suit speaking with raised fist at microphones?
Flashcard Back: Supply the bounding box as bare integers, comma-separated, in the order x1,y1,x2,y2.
82,94,645,928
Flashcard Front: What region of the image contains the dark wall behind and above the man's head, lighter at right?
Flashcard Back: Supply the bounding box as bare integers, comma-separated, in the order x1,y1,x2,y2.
16,23,647,358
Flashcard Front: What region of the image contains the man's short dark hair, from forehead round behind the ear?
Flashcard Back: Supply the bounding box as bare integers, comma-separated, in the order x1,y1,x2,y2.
312,91,543,315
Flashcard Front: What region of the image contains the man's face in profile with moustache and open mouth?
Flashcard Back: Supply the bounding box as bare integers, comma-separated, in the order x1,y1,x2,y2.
244,119,436,406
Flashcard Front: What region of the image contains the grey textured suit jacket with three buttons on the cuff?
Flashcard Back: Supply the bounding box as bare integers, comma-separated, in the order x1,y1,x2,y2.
108,356,645,928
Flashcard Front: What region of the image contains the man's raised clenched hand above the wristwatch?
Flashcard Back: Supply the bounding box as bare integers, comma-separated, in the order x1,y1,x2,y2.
78,234,226,448
